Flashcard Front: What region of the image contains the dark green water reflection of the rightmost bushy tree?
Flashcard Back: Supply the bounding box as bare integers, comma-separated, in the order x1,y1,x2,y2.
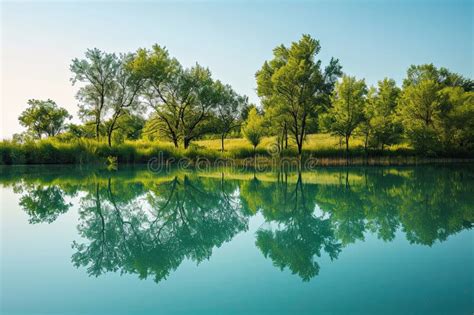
396,169,474,246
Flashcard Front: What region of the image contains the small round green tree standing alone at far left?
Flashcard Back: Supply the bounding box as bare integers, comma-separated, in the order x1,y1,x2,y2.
18,99,72,138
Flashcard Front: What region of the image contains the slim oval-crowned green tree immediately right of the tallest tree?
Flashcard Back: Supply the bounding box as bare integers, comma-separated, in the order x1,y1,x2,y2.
323,75,367,154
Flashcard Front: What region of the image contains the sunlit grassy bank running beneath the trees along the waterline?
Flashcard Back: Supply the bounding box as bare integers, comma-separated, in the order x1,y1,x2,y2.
0,134,472,165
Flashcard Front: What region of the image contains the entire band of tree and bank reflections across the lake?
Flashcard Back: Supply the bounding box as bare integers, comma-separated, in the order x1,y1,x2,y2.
0,166,474,282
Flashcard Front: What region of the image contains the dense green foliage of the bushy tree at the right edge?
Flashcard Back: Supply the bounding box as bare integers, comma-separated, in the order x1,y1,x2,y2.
399,74,474,154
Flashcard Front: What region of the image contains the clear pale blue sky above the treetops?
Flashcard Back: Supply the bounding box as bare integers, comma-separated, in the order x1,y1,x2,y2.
0,0,474,137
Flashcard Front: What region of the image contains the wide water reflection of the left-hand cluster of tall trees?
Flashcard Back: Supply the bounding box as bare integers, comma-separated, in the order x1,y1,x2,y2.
73,175,247,282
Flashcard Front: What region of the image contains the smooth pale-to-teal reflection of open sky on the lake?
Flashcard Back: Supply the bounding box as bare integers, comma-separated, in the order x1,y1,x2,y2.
1,167,474,314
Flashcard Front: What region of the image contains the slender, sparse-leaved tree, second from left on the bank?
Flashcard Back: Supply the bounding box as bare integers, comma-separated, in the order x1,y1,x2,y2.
70,48,120,141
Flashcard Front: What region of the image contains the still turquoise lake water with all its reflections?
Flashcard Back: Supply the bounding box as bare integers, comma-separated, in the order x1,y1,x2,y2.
0,165,474,314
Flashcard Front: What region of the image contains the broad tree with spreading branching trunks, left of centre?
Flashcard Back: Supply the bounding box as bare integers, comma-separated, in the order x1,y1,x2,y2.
131,45,216,148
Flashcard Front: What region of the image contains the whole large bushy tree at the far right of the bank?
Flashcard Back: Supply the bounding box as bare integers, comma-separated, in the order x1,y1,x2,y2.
398,64,474,153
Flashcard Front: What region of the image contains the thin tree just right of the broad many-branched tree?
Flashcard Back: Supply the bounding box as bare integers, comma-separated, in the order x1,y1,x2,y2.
214,81,248,152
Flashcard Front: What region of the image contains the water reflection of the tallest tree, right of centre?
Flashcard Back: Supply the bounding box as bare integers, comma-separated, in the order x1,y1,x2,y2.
246,173,341,281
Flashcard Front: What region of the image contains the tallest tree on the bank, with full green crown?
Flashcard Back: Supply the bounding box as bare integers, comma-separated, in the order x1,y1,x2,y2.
256,35,342,156
